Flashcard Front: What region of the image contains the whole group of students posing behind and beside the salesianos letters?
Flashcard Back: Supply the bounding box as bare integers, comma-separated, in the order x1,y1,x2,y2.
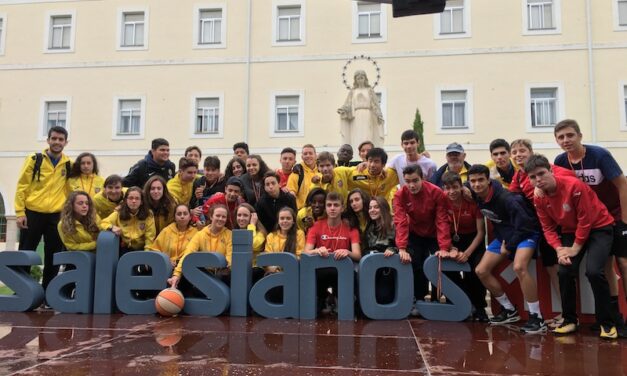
16,120,627,339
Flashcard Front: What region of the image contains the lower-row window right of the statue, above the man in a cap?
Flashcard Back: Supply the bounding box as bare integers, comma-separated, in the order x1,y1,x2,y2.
436,86,474,134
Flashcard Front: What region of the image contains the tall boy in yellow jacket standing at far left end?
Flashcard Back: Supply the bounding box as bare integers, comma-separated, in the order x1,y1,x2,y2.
15,126,71,289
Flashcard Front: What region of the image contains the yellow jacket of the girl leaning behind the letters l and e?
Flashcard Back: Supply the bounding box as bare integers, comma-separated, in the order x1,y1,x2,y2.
100,212,157,251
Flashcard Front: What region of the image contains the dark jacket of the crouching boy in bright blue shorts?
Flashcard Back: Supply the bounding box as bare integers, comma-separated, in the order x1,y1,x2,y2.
475,180,540,252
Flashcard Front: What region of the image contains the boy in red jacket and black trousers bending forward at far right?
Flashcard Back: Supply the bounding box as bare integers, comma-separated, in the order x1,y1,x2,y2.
525,155,618,339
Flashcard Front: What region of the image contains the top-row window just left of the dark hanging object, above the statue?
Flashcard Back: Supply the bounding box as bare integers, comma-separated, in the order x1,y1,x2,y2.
353,1,389,43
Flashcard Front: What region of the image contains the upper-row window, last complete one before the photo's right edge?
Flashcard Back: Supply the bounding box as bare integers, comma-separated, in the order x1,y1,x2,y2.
523,0,561,34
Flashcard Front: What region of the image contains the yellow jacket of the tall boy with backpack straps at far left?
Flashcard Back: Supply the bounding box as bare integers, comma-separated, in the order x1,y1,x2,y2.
14,150,70,217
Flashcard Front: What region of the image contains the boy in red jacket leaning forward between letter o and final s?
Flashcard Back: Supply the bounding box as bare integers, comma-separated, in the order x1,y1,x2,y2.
392,165,452,306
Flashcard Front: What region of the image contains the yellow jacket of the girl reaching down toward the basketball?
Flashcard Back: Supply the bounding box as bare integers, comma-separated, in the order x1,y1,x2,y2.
172,226,233,277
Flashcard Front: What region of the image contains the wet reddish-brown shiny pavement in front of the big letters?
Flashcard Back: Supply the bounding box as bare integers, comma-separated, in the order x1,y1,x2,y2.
0,311,627,376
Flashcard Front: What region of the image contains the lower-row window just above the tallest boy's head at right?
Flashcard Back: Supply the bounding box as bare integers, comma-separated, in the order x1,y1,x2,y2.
525,83,565,132
